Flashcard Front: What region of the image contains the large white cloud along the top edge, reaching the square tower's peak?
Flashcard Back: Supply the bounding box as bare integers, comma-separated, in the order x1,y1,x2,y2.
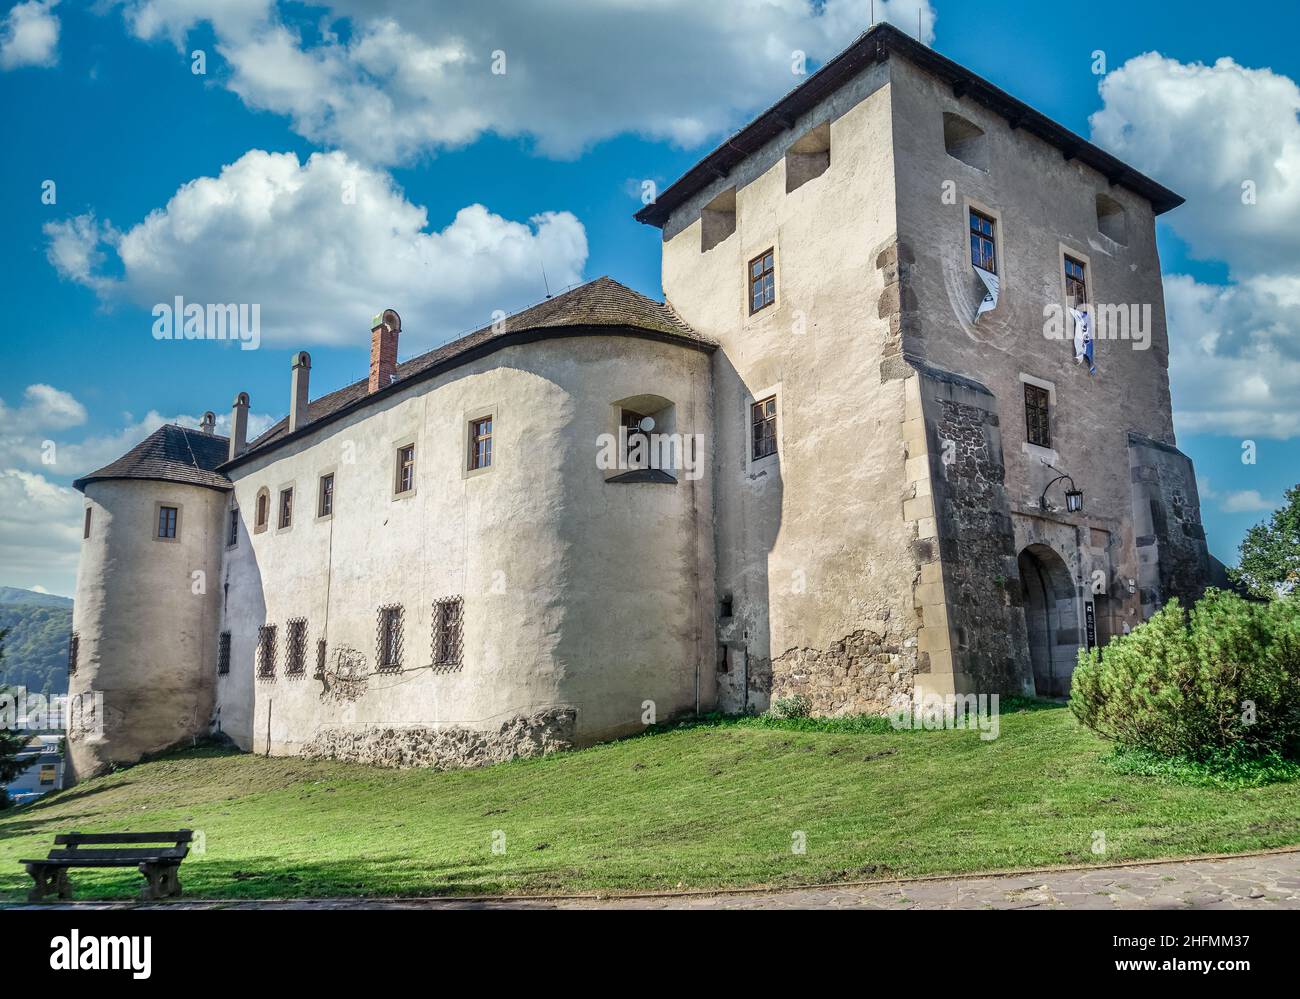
114,0,935,164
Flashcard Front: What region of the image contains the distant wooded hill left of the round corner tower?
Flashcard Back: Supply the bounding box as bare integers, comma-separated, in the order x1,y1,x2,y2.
0,587,73,695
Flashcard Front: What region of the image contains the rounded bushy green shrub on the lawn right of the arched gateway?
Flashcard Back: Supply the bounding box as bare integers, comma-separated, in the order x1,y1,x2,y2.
1070,589,1300,760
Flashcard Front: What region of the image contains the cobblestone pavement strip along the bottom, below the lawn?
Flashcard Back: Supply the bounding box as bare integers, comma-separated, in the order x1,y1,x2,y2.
13,849,1300,909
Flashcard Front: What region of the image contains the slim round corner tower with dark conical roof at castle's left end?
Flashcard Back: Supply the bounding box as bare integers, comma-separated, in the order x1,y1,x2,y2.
68,418,230,780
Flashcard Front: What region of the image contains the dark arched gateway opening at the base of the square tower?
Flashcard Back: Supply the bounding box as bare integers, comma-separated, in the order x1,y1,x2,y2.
1017,544,1083,697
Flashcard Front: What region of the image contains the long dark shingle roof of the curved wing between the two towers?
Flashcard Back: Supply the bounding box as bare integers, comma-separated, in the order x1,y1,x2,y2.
229,277,716,467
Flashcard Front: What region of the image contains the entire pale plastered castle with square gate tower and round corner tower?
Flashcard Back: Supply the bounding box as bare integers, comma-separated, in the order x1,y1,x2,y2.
69,25,1209,777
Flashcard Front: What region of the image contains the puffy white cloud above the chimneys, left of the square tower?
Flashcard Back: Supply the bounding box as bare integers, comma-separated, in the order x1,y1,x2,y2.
46,150,588,351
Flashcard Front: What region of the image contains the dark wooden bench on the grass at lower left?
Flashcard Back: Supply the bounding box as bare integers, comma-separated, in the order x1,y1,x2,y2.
18,829,194,901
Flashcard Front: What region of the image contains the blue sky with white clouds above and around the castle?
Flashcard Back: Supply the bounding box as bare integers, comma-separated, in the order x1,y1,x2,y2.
0,0,1300,593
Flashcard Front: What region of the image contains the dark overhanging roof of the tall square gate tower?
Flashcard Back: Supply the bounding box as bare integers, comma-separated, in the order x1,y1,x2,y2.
634,22,1183,228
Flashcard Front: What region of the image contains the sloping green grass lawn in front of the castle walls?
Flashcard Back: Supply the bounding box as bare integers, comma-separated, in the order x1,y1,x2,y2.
0,705,1300,901
